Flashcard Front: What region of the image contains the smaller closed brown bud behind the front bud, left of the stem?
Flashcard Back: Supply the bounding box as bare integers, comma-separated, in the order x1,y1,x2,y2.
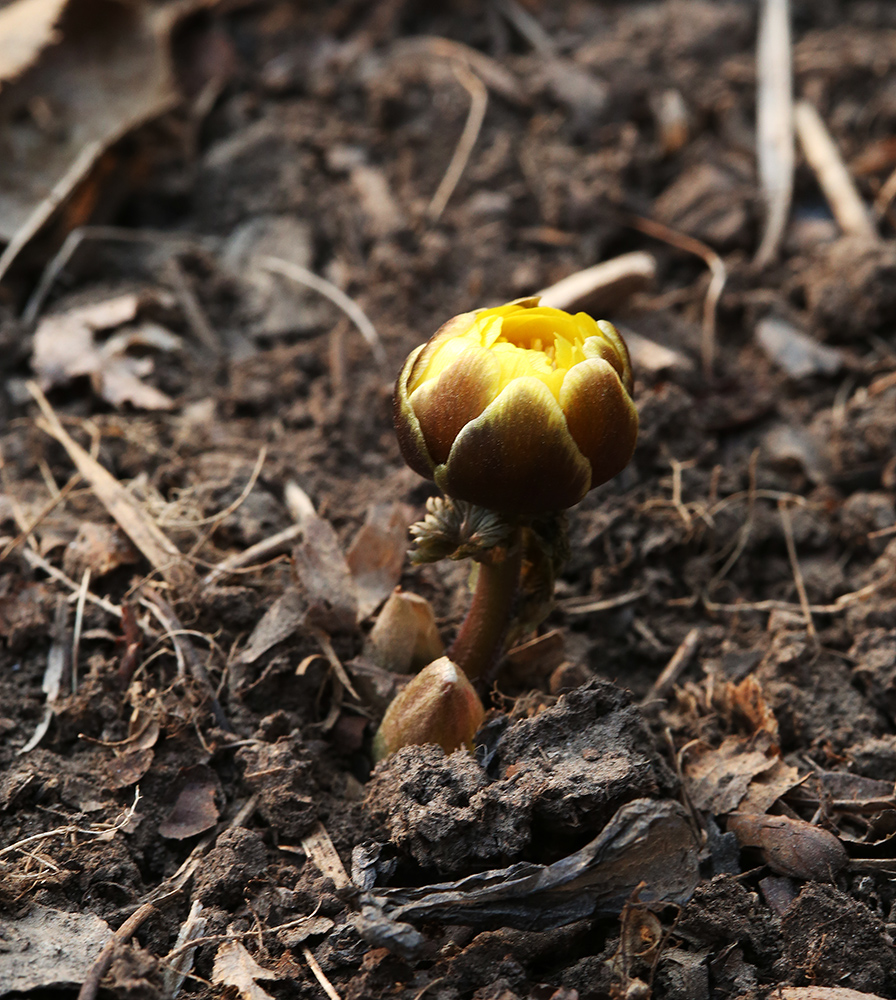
367,587,445,674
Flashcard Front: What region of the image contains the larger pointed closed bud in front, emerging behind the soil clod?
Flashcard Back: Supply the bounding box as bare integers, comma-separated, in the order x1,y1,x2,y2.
373,656,485,761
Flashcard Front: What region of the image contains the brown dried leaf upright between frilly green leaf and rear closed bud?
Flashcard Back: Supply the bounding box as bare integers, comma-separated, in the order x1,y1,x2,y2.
346,503,414,620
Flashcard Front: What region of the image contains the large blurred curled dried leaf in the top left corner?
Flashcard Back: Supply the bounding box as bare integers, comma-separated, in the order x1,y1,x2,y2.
0,0,175,277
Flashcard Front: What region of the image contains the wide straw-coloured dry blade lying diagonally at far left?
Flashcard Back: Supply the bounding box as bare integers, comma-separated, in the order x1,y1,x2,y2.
28,382,195,591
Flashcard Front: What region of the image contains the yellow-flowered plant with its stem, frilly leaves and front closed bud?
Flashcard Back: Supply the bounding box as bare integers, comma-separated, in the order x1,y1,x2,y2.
375,298,638,758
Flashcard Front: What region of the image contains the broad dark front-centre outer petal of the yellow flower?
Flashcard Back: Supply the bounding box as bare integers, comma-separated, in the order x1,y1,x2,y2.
435,377,592,514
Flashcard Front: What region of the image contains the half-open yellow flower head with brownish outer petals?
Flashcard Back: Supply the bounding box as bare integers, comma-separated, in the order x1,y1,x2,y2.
394,298,638,514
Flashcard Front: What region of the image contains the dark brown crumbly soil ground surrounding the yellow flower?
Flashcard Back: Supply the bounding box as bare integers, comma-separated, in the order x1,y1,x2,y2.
0,0,896,1000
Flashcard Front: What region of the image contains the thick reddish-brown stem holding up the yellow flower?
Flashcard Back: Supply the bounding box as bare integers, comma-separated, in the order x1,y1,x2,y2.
448,528,523,683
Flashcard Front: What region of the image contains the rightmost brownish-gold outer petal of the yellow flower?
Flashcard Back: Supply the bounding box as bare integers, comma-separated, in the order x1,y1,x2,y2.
560,358,638,487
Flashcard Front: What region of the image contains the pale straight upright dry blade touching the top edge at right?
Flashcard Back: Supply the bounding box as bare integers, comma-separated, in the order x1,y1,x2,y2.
755,0,795,267
